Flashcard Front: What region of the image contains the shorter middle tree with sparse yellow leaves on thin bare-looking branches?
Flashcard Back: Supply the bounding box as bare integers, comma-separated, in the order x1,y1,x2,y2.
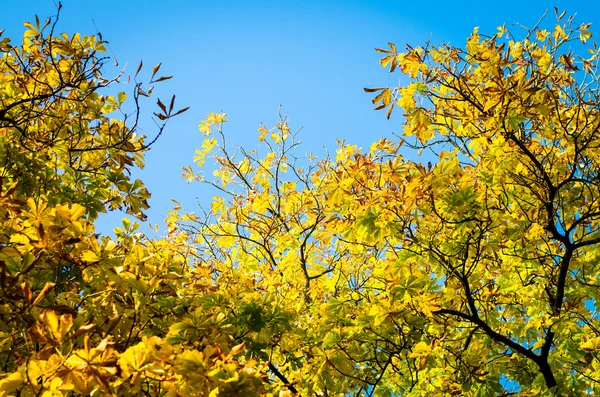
178,115,426,395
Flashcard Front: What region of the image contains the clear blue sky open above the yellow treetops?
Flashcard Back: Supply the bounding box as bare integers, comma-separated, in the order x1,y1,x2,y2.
0,0,600,232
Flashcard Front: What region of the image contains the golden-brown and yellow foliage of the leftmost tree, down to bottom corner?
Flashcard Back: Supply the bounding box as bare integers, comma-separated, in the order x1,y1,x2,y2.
0,6,263,396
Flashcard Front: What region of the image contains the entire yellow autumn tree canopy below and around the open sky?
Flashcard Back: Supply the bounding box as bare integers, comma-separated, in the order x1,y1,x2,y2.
0,8,600,397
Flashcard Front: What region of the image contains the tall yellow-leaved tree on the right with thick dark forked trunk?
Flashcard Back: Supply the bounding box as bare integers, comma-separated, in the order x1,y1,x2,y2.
360,12,600,393
